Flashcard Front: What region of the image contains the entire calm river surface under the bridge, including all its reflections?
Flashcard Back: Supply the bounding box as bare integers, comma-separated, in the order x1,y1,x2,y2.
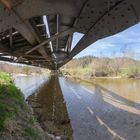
14,76,140,140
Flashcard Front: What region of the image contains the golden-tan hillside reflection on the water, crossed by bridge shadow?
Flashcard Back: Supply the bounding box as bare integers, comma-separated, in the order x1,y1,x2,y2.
75,79,140,111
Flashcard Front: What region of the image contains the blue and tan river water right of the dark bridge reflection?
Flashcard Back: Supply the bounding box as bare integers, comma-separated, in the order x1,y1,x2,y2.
61,79,140,140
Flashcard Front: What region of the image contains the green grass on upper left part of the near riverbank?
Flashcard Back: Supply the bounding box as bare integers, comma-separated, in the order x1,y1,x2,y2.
0,72,24,132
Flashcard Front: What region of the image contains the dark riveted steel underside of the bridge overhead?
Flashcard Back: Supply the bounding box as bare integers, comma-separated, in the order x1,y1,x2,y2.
0,0,140,69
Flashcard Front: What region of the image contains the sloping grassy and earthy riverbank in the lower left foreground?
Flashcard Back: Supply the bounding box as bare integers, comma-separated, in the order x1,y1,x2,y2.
0,72,49,140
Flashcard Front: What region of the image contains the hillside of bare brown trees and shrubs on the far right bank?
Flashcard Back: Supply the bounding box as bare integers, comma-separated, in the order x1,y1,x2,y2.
61,56,140,78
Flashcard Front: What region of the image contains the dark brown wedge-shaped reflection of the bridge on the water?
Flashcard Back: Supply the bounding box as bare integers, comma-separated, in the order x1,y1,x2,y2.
27,76,72,140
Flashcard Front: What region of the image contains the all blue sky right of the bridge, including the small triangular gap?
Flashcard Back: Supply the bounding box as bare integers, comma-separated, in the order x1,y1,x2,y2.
72,23,140,60
